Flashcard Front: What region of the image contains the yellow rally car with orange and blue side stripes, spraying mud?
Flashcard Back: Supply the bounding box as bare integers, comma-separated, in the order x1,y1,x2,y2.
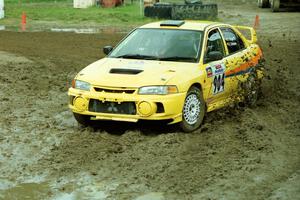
68,20,263,132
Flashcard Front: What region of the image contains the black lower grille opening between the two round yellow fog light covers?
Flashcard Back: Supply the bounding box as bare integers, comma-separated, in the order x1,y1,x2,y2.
89,99,136,115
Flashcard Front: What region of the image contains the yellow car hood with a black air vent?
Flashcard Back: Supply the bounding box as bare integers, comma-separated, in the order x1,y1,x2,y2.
76,58,197,88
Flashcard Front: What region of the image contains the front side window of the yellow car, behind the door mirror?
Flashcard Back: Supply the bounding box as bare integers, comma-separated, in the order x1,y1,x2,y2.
204,29,225,63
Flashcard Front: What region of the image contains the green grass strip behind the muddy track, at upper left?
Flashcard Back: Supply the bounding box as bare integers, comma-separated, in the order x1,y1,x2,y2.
0,0,153,26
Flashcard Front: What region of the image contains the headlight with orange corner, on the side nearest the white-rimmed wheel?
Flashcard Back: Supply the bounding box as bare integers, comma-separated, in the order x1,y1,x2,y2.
139,85,178,95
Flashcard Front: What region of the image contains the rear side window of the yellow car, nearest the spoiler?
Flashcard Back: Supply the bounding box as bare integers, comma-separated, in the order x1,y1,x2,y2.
221,28,245,54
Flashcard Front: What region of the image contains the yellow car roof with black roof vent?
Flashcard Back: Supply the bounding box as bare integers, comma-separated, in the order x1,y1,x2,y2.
140,20,221,31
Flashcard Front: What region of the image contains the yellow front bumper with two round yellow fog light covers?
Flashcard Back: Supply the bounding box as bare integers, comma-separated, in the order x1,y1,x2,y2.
68,88,186,124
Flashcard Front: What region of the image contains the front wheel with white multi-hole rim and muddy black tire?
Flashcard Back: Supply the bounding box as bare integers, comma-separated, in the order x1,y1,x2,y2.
180,86,206,132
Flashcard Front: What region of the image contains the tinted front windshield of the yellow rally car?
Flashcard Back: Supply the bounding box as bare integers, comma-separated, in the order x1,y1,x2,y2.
109,29,202,62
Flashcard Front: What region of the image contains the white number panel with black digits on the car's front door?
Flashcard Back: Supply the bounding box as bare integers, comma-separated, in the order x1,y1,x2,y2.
206,63,225,95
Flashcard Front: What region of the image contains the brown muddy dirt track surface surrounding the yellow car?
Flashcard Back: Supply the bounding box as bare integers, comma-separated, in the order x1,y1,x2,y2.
0,1,300,200
